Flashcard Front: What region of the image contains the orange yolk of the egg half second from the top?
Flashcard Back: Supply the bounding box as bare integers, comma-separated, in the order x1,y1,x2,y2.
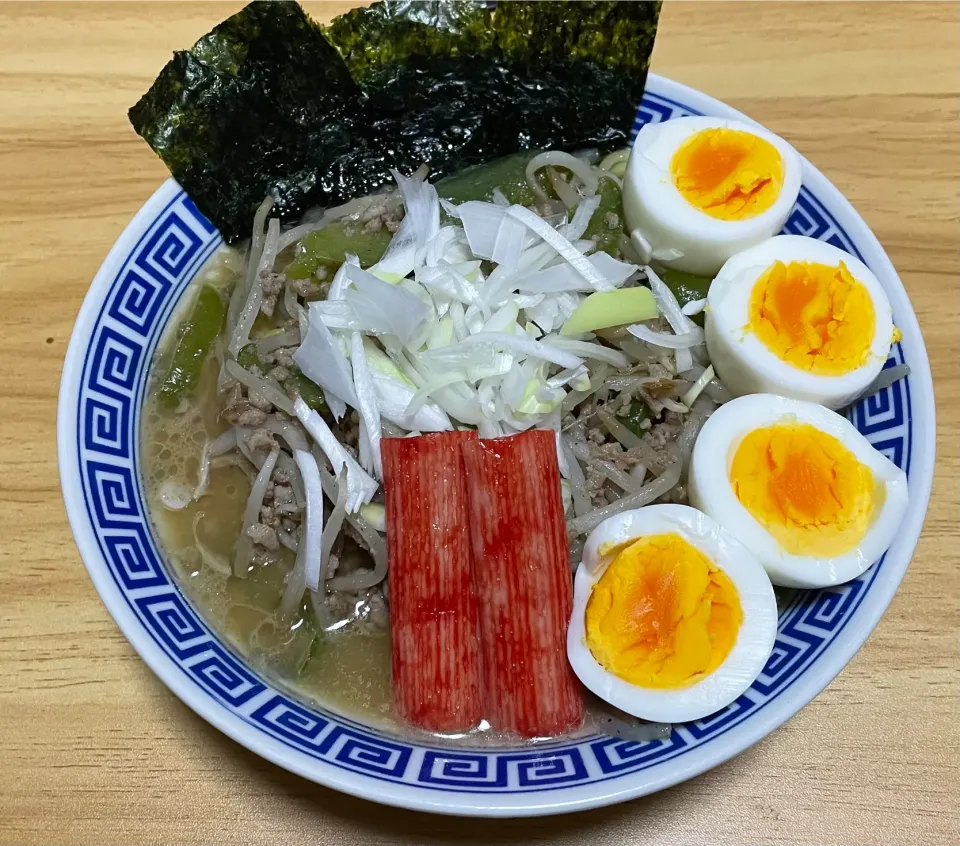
749,261,876,376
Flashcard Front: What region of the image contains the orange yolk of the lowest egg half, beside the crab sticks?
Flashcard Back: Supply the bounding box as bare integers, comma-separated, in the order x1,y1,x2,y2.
585,533,743,689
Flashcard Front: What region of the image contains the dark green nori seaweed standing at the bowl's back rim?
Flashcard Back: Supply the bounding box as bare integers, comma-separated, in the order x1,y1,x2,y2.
130,0,660,241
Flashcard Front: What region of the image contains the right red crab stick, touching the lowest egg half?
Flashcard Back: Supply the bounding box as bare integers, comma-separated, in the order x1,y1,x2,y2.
460,430,583,737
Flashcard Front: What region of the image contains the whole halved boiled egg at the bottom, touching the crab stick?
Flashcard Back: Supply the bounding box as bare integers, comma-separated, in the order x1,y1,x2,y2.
567,505,777,722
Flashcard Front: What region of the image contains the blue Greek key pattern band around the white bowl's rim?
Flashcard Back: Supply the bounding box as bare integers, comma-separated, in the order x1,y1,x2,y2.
69,93,912,794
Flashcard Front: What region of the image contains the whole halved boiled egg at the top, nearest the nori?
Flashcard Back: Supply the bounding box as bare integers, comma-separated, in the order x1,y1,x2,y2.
623,117,801,276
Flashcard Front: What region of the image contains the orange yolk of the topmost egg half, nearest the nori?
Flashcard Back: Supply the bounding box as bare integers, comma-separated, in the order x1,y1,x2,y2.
670,129,784,220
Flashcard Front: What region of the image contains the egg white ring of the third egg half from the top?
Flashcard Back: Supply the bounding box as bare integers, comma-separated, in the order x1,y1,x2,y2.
688,394,907,588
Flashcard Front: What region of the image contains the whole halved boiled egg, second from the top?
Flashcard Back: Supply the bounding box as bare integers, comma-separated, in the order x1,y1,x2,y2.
705,235,897,408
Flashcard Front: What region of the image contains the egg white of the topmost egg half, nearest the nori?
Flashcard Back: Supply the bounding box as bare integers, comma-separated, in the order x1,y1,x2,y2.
623,117,802,276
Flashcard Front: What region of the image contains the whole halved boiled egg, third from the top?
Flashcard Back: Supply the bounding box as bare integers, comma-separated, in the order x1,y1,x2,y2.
689,394,907,588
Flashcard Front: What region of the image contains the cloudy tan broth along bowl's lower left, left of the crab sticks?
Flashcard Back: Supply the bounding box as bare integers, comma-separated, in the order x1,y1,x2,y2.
141,271,391,726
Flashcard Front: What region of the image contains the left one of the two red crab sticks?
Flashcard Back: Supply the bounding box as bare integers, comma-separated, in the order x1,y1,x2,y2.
381,432,482,731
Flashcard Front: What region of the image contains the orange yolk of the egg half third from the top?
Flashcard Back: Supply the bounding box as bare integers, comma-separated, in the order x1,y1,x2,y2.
730,423,883,557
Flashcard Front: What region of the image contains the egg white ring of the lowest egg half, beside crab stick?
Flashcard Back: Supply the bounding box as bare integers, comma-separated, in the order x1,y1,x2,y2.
567,505,777,722
